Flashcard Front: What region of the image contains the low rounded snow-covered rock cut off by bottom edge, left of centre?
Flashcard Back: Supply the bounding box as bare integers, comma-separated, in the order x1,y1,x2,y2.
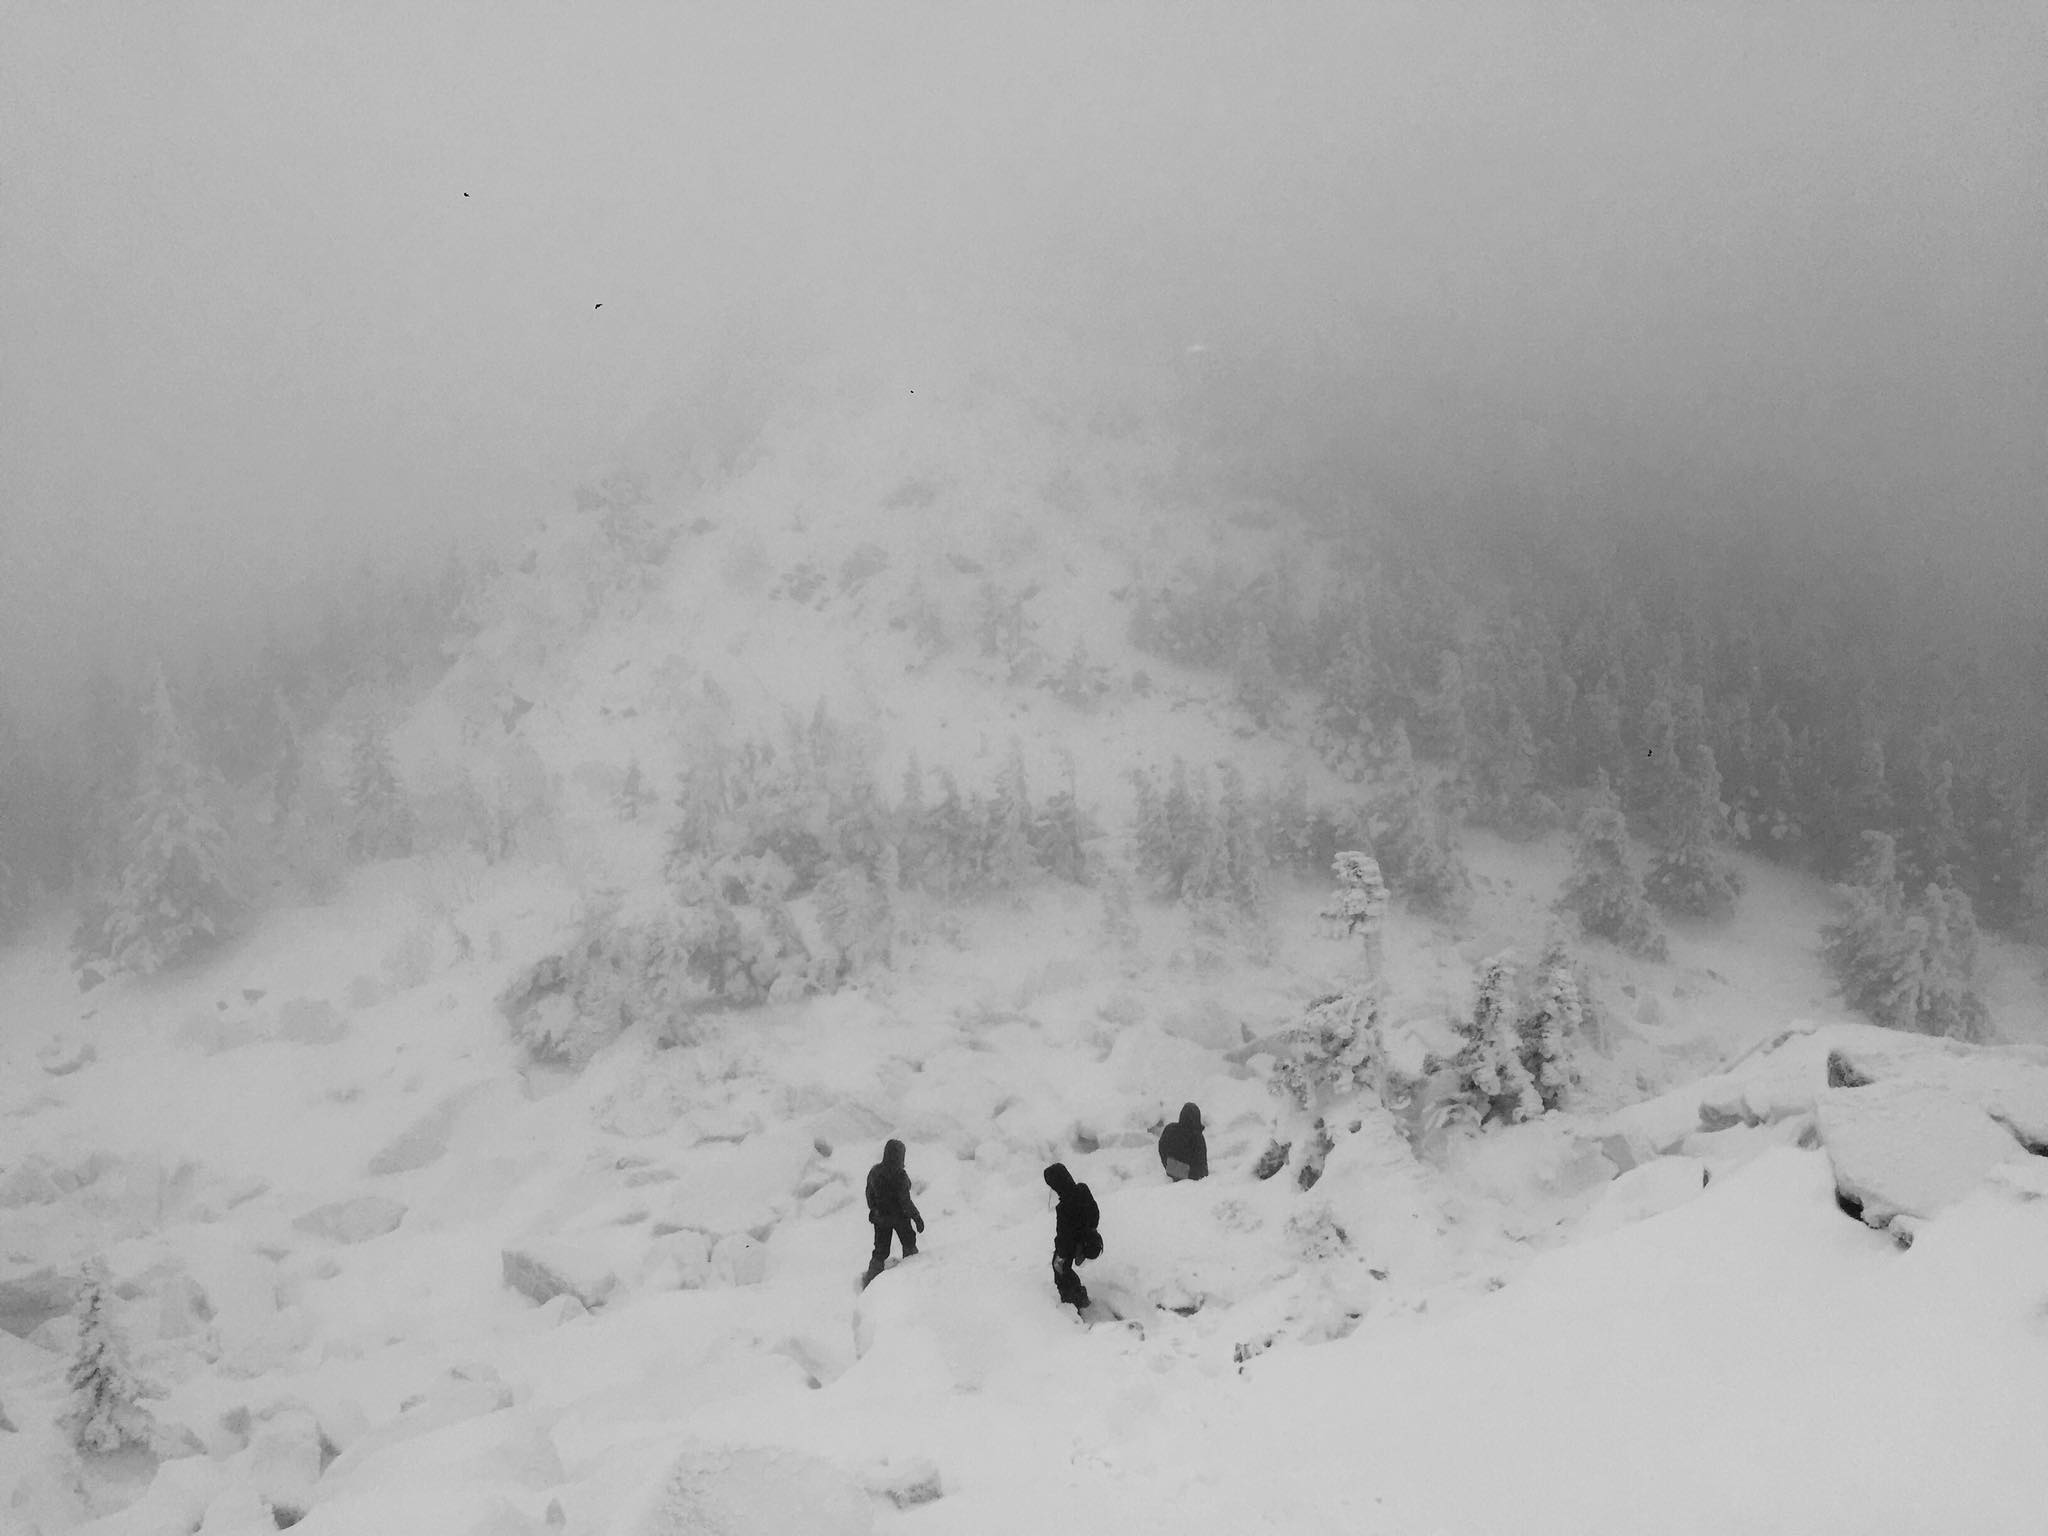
616,1444,874,1536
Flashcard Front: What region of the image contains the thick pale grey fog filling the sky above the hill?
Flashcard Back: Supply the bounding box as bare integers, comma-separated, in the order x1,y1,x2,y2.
0,0,2048,716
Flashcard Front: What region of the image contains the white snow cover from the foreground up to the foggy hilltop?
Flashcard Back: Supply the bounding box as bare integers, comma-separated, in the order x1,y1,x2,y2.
0,354,2048,1536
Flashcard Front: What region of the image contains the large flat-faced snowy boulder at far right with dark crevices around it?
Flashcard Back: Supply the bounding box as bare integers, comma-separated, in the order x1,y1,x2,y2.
1819,1079,2028,1227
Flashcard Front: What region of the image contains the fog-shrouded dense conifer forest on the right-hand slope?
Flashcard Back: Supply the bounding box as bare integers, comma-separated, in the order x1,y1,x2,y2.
1130,526,2048,938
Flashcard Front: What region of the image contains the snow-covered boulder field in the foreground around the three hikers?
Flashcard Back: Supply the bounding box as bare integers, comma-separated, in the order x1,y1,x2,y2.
0,889,2048,1536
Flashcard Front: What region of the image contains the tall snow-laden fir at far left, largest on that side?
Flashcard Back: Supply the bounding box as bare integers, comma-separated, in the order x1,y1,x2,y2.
72,672,246,975
